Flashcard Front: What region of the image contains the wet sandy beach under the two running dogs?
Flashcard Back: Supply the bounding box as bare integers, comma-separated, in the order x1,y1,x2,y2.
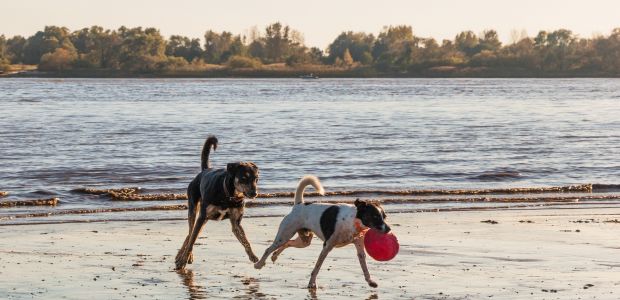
0,207,620,299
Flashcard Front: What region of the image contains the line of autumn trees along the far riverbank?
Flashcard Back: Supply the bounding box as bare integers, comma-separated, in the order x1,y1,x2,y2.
0,23,620,76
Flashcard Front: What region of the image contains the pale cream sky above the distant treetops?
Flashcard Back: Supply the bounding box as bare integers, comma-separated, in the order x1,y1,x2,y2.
0,0,620,49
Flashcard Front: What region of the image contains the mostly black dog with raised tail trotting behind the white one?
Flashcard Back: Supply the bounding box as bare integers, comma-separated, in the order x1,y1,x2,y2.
176,136,258,270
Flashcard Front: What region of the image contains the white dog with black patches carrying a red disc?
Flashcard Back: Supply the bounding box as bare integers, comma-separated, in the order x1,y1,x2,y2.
254,176,390,289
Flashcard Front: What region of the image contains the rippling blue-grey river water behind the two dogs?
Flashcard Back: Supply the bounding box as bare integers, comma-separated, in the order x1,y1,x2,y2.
0,79,620,223
